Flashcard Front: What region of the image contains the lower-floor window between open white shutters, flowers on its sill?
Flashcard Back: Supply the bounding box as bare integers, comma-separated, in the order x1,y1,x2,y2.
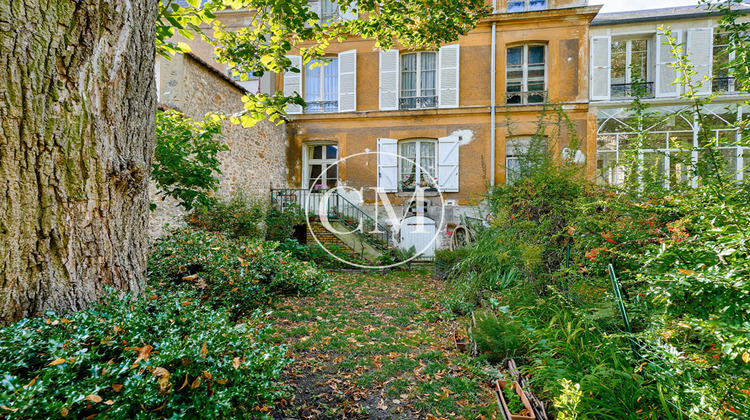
399,140,437,191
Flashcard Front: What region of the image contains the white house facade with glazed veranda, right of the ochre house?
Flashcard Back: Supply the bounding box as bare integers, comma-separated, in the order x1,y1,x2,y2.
590,6,750,187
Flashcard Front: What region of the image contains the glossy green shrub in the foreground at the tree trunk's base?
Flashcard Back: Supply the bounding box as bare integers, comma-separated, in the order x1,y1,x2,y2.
0,292,291,420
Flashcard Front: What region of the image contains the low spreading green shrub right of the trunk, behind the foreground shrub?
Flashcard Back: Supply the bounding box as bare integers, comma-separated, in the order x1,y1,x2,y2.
149,229,329,319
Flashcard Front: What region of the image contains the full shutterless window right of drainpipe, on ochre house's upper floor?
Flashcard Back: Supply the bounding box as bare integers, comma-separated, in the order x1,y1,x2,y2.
505,45,545,104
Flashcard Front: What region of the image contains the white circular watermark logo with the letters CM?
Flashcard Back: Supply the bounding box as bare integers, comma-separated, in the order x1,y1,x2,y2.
302,151,445,269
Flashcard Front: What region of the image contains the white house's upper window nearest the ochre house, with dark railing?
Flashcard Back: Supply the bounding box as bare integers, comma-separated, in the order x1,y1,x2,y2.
610,39,654,98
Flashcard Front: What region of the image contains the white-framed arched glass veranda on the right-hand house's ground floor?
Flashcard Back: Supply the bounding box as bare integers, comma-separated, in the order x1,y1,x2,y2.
597,104,750,188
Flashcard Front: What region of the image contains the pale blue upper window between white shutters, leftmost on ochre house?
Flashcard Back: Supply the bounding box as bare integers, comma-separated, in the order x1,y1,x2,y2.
305,58,339,113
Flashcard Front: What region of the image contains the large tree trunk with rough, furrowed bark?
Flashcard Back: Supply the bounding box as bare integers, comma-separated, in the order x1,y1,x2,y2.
0,0,157,324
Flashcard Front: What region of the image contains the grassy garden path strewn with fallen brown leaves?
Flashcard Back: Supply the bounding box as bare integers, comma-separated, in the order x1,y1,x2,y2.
271,272,499,420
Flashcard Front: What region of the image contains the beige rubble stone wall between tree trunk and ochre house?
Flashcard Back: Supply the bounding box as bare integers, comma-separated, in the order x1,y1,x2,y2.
150,54,288,238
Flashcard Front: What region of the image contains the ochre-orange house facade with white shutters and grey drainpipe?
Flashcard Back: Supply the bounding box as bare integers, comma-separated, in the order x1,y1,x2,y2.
276,0,599,246
